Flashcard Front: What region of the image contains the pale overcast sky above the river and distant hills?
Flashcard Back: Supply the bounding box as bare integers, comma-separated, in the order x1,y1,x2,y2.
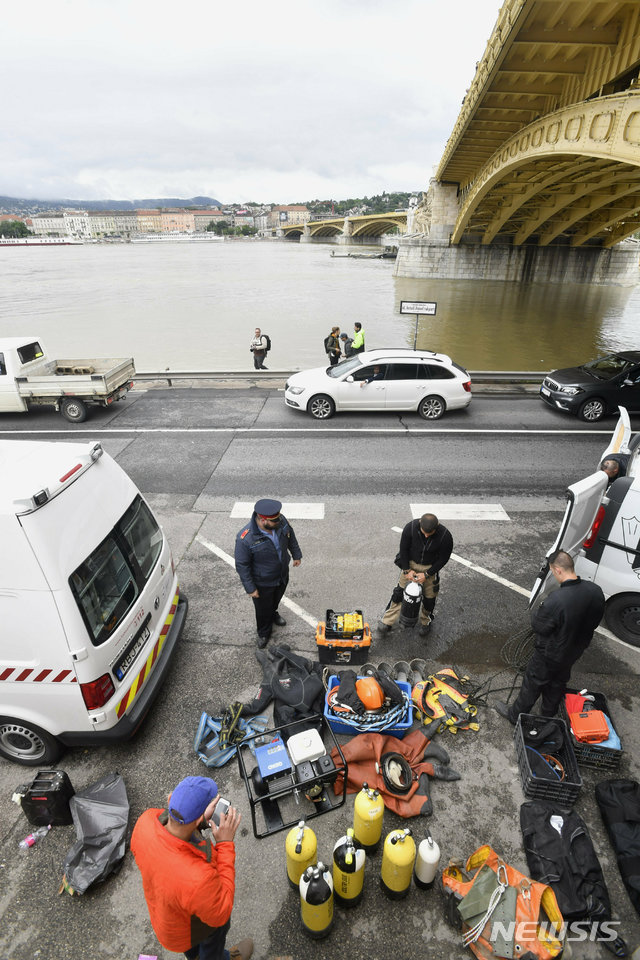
0,0,500,203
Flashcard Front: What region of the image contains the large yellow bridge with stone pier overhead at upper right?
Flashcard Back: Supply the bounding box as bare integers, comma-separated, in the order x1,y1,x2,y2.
396,0,640,283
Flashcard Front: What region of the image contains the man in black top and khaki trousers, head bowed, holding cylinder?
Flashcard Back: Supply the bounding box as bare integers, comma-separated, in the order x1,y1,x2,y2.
378,513,453,636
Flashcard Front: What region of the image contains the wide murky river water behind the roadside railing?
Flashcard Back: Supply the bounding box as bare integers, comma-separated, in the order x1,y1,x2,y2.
0,241,640,371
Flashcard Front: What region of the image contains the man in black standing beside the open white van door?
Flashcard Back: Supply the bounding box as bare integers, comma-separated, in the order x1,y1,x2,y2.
495,550,604,724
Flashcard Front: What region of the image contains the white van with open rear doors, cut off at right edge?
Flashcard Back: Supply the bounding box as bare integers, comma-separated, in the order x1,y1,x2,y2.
529,407,640,647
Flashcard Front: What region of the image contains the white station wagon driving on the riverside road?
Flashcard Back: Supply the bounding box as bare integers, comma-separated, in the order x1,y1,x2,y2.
284,347,471,420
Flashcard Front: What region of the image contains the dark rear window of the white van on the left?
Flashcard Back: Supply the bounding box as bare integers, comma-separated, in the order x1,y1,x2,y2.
69,496,163,646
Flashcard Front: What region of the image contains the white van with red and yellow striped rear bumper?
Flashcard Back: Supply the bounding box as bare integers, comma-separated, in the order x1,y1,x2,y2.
0,440,187,766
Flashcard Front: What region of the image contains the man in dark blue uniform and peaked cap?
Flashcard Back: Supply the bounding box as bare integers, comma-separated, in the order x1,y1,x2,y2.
235,499,302,649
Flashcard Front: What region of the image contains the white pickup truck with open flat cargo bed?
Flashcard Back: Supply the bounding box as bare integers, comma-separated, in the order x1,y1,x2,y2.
0,337,136,423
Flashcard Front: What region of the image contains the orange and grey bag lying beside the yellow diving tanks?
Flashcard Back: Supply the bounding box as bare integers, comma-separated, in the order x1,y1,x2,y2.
442,845,563,960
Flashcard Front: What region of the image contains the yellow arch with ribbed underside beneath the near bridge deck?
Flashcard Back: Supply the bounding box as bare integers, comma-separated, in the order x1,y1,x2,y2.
451,90,640,247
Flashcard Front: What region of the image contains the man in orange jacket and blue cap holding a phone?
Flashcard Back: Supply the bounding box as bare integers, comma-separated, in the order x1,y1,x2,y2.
131,777,253,960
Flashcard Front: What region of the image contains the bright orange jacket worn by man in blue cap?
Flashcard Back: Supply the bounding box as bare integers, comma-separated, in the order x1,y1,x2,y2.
131,809,236,953
